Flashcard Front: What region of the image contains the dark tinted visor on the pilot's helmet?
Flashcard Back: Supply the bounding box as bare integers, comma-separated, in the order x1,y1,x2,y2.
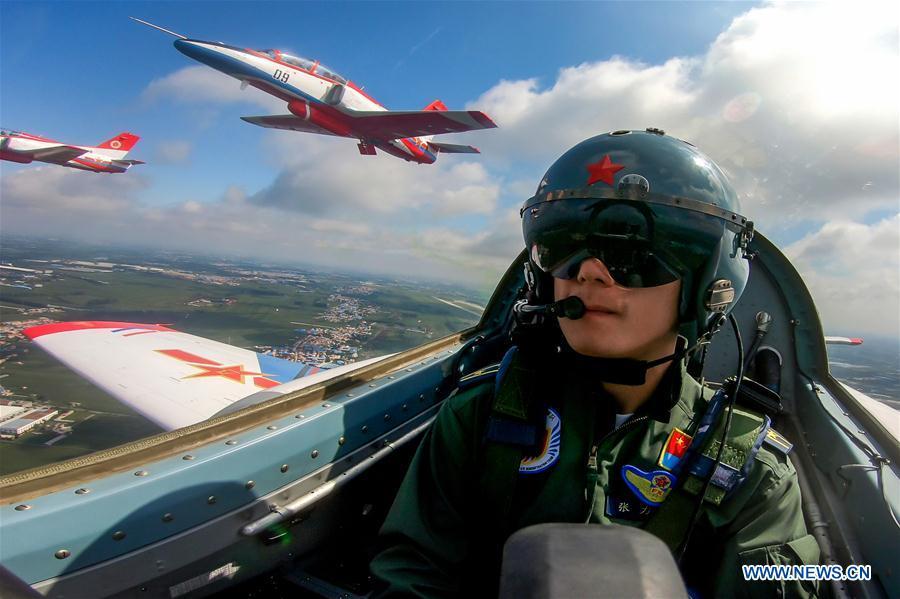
522,198,724,287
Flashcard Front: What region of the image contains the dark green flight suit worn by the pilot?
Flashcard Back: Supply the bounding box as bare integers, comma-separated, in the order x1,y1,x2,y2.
371,352,819,597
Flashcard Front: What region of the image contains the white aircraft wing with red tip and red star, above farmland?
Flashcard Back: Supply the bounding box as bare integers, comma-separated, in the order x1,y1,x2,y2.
24,321,326,430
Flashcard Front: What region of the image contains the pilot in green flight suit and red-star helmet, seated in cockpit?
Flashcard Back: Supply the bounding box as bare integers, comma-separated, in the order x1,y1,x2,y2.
371,129,819,597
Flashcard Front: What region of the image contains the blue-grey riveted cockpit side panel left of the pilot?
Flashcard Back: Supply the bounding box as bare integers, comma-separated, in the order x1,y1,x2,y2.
0,345,460,597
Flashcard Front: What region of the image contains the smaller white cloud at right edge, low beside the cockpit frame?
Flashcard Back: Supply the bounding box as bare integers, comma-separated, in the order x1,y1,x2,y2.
785,214,900,337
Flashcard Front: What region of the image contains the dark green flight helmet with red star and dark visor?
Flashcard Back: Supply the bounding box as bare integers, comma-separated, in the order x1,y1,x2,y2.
520,128,753,344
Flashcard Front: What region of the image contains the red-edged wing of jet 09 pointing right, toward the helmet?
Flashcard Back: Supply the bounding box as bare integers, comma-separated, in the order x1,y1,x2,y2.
348,110,497,139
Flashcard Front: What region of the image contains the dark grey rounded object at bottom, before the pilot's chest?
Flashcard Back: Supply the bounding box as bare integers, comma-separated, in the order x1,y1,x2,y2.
500,524,688,599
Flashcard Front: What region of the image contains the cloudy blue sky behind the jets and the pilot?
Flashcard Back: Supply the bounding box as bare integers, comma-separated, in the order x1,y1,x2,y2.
0,1,900,335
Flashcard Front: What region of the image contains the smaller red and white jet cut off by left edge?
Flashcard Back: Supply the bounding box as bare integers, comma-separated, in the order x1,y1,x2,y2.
0,129,144,173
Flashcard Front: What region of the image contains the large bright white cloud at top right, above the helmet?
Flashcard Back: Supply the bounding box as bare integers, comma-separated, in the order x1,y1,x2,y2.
470,3,900,232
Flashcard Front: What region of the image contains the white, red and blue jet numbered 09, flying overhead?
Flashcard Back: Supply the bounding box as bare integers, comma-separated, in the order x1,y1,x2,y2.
131,17,497,164
